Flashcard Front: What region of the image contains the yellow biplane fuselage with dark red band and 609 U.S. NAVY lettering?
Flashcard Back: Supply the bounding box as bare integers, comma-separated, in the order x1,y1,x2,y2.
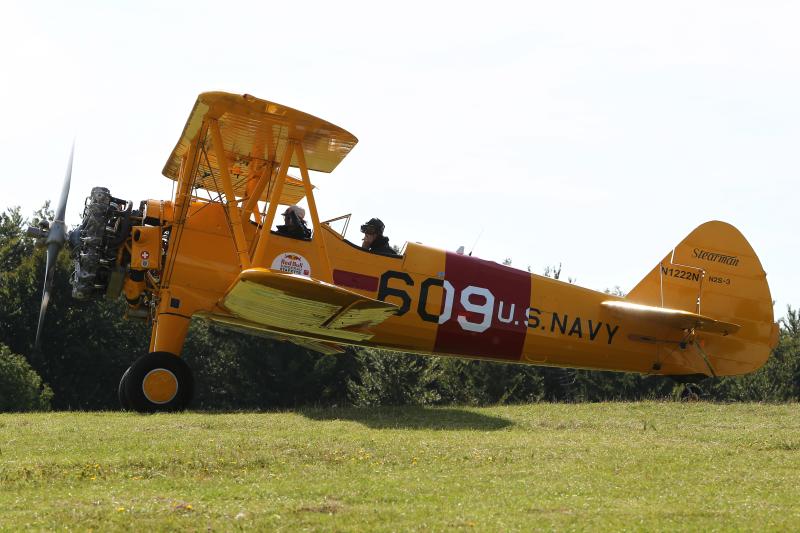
156,197,702,374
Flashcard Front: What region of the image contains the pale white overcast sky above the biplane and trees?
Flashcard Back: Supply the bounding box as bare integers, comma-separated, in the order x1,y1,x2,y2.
0,0,800,318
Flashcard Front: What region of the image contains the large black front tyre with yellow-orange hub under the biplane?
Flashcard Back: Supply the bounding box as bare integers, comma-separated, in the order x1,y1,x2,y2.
123,352,194,413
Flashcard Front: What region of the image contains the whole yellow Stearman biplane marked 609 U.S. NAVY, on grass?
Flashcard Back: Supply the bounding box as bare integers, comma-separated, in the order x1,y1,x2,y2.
30,92,778,412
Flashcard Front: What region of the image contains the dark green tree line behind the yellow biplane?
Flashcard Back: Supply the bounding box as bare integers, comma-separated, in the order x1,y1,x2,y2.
0,206,800,411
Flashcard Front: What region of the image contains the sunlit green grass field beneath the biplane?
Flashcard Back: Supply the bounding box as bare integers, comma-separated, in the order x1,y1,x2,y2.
0,403,800,531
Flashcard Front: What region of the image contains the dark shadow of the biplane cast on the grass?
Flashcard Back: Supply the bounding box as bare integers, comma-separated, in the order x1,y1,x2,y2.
299,407,514,431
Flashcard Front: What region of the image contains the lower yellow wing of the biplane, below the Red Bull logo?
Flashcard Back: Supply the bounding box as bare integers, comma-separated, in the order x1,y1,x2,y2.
222,268,397,341
